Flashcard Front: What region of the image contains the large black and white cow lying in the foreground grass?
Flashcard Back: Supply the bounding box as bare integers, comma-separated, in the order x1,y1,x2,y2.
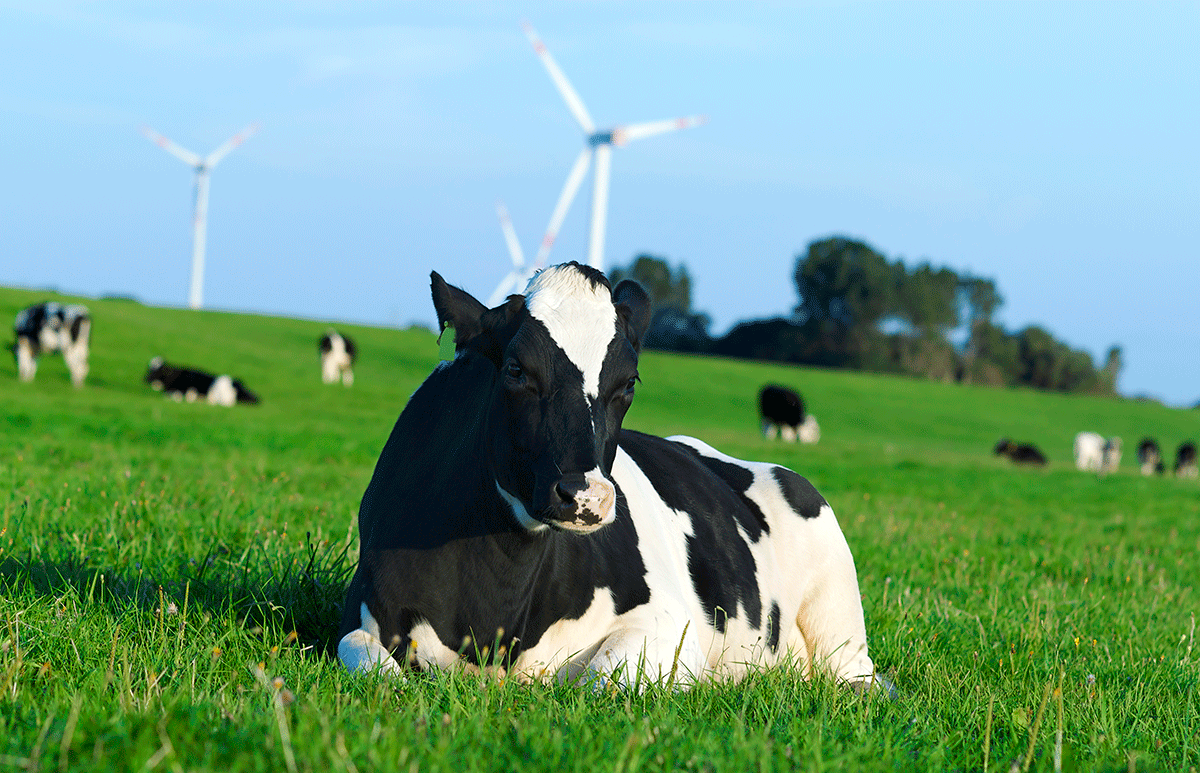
337,263,888,689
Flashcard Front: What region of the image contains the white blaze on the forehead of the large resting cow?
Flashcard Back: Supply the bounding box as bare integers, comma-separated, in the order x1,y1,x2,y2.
526,265,617,397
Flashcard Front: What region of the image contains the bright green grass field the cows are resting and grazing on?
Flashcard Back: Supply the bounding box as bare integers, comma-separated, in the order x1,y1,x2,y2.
0,289,1200,772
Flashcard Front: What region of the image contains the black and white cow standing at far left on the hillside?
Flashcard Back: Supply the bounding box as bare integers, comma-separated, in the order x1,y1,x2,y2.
12,300,91,387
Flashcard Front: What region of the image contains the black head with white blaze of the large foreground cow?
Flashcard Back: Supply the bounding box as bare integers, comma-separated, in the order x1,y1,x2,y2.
432,263,650,532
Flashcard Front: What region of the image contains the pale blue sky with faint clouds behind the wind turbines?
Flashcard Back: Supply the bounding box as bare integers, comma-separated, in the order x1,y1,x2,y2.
0,0,1200,406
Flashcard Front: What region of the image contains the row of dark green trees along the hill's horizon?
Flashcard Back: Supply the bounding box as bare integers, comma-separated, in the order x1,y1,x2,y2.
612,236,1121,394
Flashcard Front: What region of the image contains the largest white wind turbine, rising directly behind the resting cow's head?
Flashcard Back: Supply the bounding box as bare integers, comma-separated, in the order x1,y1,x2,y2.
522,22,708,271
